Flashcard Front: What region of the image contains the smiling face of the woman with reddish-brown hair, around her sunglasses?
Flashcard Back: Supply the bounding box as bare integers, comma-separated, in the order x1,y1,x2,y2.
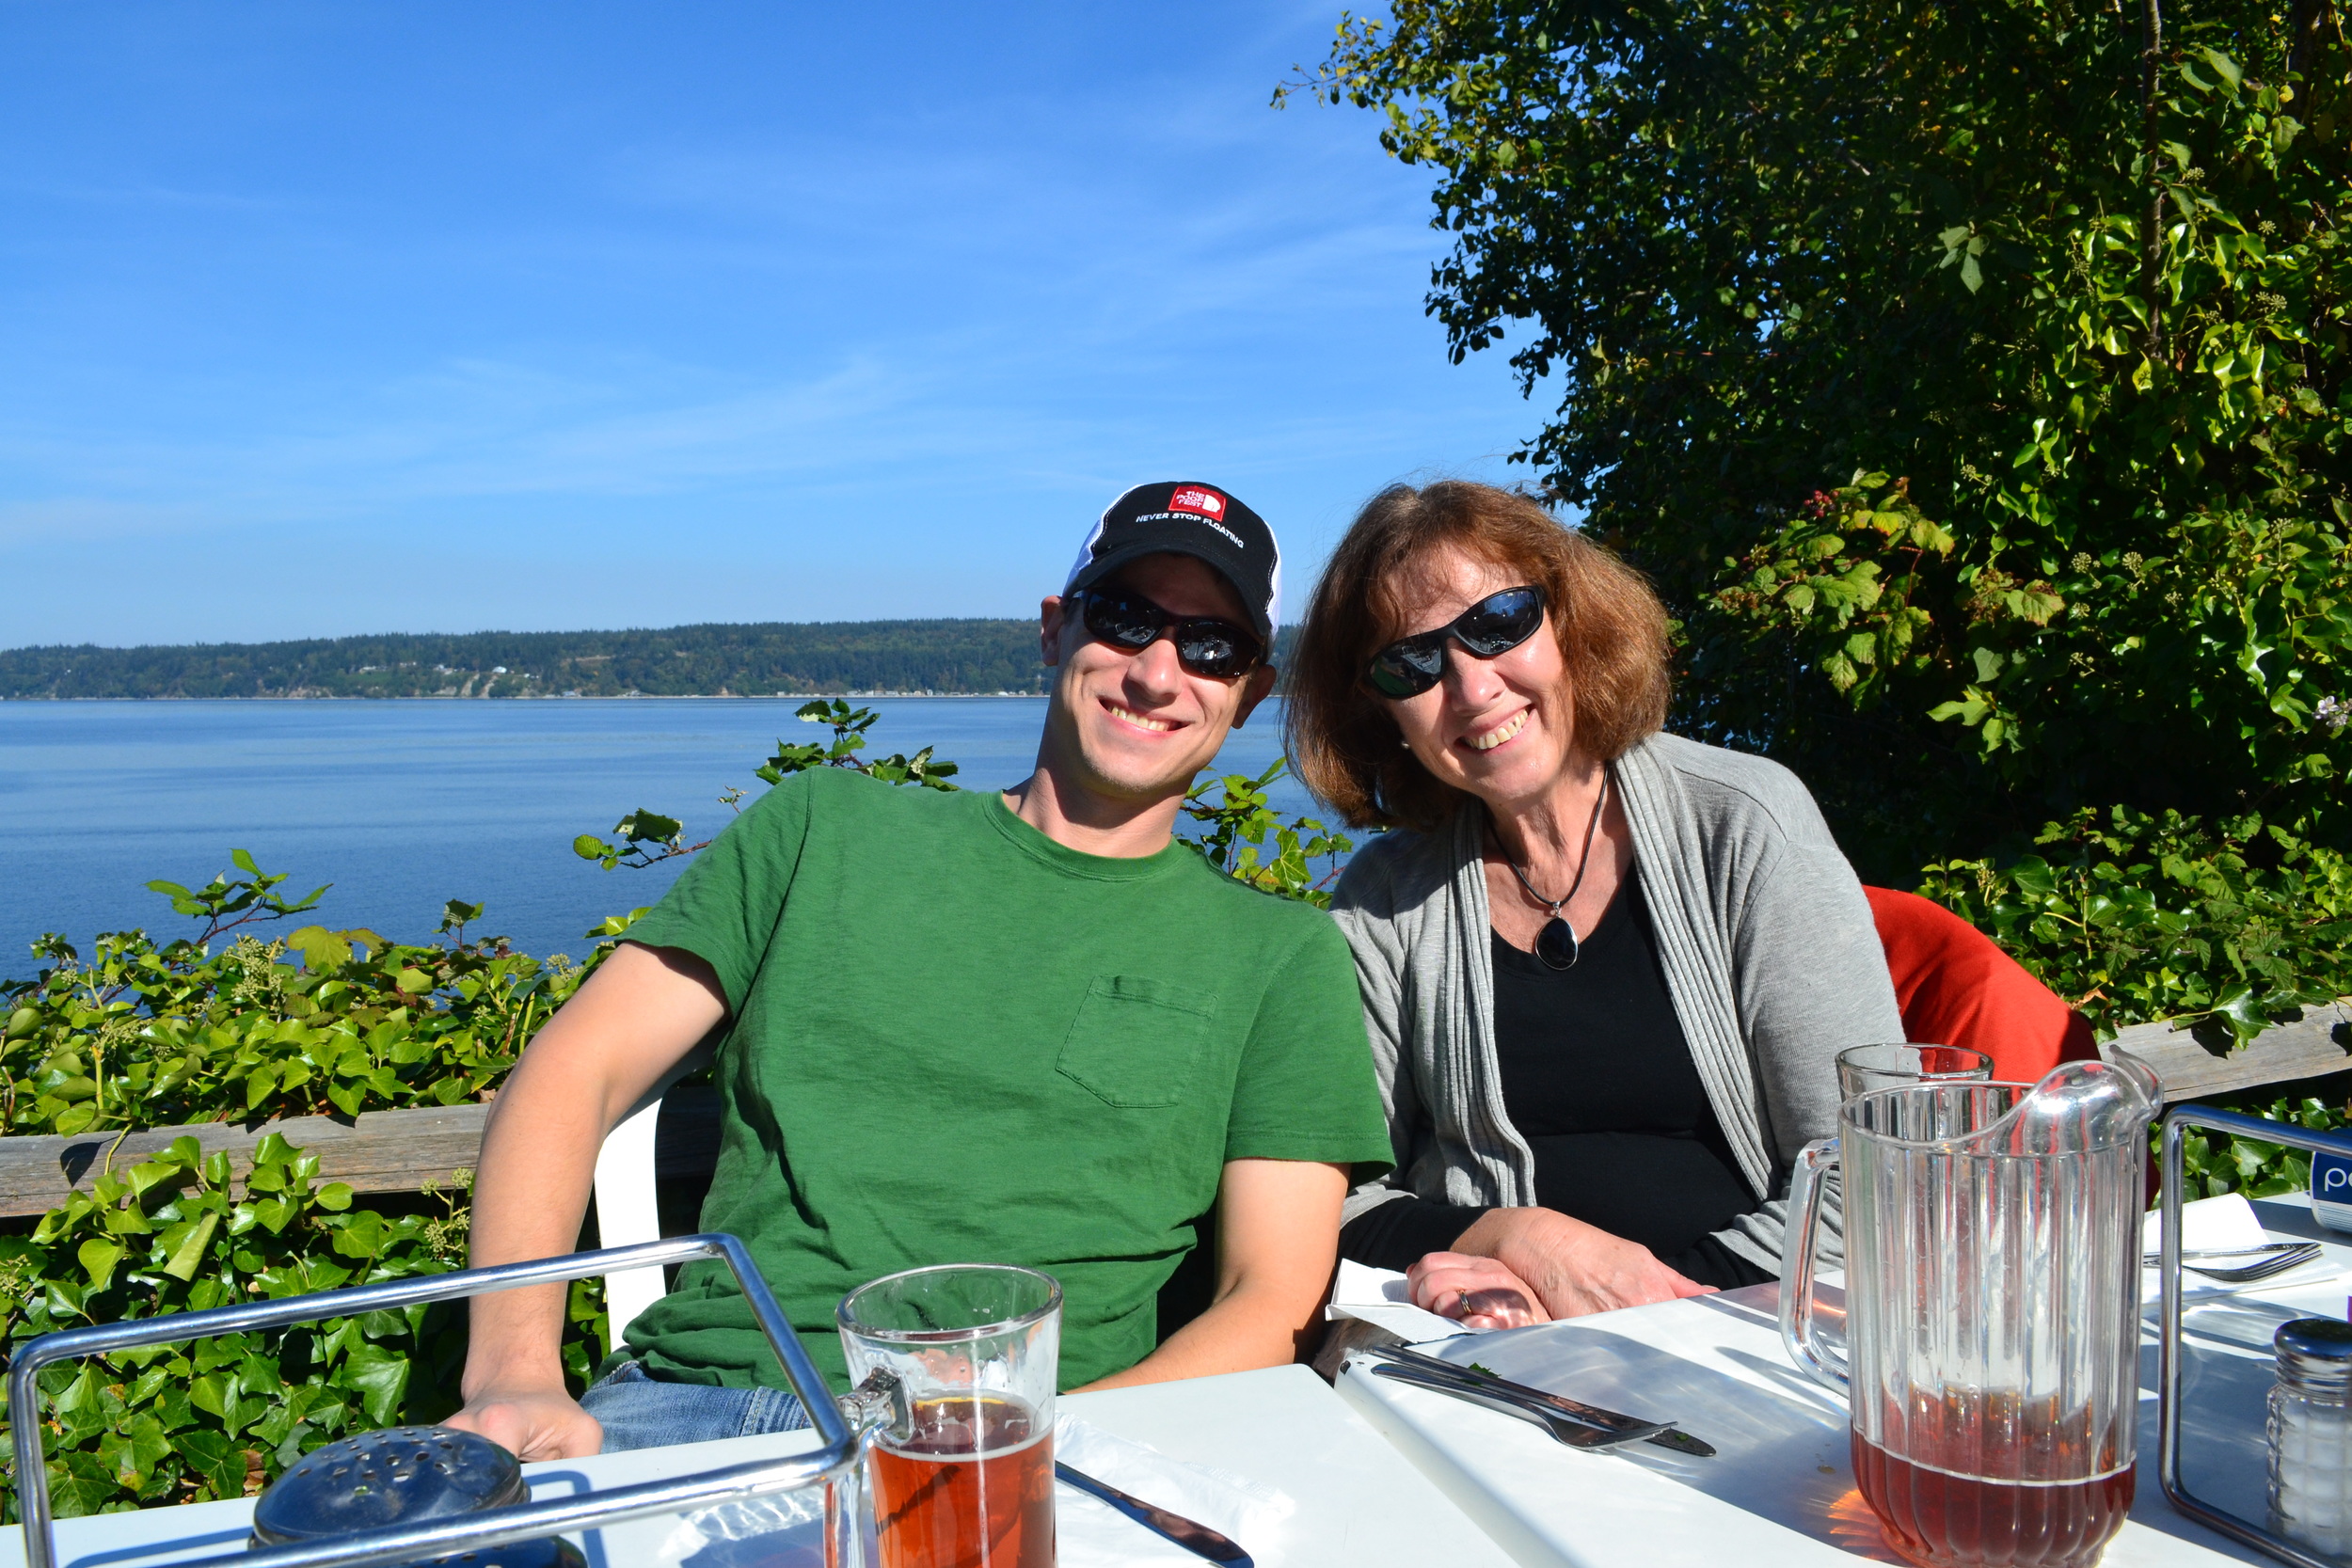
1381,546,1581,816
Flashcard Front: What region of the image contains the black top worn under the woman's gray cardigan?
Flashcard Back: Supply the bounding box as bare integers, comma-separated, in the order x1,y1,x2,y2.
1341,879,1773,1289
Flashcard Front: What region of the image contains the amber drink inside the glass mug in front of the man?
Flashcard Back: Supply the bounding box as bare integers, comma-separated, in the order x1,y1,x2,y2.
870,1394,1054,1568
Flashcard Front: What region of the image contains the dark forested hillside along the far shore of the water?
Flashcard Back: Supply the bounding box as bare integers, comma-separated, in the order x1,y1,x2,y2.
0,621,1044,701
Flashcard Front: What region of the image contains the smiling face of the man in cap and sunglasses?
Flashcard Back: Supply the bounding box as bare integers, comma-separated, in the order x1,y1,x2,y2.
1040,555,1275,806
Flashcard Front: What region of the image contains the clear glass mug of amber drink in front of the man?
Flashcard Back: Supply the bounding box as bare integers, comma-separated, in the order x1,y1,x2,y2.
835,1262,1061,1568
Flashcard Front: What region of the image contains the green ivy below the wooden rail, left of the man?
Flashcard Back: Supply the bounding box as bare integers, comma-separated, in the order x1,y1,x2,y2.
0,1133,605,1519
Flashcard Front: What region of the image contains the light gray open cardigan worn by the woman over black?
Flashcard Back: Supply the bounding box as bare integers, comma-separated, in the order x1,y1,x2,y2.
1331,734,1903,1275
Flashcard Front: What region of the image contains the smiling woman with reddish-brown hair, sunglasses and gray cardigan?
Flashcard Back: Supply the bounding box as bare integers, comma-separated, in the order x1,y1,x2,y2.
1287,482,1903,1328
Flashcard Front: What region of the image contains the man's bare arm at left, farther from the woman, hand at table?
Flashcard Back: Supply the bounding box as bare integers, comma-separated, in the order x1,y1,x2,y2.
450,942,727,1460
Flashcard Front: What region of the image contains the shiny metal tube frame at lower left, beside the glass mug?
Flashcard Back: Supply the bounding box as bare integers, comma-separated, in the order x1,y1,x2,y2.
8,1234,859,1568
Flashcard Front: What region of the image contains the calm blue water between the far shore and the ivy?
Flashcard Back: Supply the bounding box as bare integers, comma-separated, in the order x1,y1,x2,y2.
0,698,1308,978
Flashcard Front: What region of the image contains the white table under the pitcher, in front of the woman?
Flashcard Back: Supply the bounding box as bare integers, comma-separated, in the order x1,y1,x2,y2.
1339,1196,2352,1568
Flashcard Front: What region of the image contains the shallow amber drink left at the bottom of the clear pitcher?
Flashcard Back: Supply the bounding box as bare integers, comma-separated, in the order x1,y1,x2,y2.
1853,1432,2131,1568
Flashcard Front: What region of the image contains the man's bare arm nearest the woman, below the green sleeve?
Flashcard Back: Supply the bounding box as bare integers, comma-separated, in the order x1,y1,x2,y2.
1087,1159,1348,1389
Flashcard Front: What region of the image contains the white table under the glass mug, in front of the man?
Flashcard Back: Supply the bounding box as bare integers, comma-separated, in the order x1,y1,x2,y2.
0,1366,1510,1568
